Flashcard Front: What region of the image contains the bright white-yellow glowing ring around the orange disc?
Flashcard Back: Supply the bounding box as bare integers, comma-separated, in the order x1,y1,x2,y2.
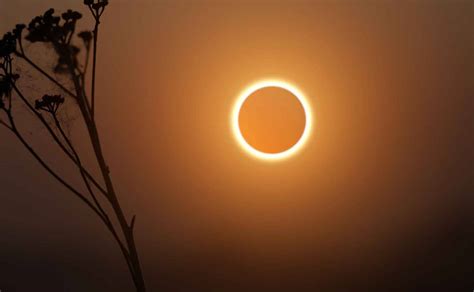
231,80,312,160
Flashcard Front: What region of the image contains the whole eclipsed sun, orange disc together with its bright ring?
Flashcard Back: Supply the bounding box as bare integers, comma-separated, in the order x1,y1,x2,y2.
231,80,312,160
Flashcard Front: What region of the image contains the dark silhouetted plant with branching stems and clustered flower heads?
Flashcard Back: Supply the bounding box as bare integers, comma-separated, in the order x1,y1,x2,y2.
0,0,146,292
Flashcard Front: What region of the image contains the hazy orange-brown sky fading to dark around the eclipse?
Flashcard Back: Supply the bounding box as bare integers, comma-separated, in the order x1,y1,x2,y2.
0,0,474,292
